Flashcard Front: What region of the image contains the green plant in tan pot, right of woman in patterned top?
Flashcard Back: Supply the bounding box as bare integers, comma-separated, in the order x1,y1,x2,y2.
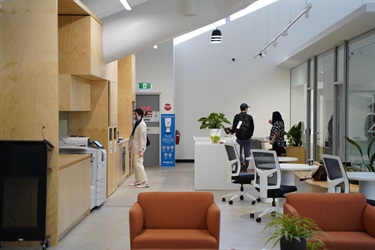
285,121,306,163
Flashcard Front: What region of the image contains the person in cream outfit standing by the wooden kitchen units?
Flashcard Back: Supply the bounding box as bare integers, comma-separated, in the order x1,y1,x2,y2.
129,108,149,188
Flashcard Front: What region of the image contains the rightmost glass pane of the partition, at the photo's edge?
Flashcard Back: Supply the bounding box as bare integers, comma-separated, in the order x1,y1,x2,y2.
347,30,375,164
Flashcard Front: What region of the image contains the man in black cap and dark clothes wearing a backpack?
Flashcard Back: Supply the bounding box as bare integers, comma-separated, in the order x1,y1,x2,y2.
231,103,254,172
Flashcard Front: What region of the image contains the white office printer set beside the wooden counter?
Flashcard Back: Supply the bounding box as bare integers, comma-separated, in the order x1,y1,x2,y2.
59,137,107,209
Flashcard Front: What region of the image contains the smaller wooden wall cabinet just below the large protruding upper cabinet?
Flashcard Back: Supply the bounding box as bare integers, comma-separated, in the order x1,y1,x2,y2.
59,74,90,111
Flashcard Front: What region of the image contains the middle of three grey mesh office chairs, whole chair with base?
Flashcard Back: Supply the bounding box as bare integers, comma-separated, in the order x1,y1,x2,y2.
250,149,297,222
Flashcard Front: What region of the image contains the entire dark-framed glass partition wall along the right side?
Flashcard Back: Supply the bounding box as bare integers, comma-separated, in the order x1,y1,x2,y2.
290,30,375,161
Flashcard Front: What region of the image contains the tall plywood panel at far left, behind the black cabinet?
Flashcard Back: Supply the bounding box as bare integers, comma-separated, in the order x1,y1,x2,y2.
0,0,58,245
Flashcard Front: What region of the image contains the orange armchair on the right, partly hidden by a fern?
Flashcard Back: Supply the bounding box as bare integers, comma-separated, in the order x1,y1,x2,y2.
284,193,375,250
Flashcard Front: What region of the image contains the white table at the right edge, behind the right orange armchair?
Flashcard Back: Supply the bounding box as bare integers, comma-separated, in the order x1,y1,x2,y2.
346,172,375,200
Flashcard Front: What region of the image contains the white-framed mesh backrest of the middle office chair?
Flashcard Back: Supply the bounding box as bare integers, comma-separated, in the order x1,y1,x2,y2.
250,149,281,198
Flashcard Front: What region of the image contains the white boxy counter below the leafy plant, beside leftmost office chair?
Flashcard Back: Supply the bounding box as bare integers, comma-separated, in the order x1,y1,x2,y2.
194,140,239,190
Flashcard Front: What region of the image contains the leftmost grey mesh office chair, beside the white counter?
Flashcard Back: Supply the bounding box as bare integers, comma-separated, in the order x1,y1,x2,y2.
222,143,256,205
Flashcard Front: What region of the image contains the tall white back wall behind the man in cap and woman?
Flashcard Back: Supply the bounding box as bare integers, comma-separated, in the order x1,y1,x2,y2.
137,0,374,159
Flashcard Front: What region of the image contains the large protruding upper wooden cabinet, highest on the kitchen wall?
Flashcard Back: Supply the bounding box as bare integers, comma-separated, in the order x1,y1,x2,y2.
59,15,105,79
